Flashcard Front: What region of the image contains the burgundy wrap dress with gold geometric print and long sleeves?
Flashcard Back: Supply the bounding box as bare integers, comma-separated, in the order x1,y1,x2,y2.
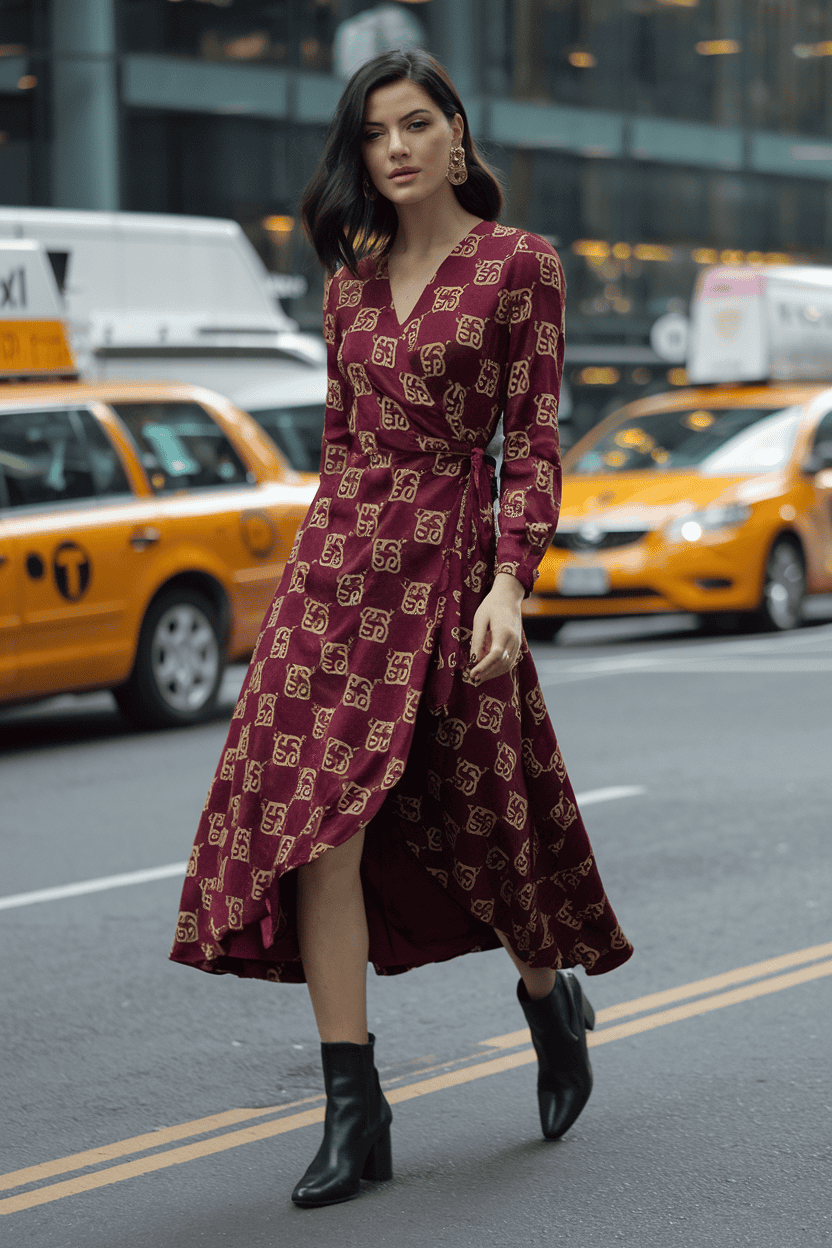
171,221,632,982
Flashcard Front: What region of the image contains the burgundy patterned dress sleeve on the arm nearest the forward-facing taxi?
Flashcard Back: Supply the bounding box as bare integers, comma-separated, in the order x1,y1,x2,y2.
495,245,565,597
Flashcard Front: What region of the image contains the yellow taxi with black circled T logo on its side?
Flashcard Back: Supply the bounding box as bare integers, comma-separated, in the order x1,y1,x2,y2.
0,381,317,725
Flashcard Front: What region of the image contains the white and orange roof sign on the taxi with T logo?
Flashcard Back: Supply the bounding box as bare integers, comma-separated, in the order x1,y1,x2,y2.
0,238,77,381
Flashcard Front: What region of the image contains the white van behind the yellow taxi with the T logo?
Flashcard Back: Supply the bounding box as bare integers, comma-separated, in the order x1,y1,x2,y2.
0,208,327,472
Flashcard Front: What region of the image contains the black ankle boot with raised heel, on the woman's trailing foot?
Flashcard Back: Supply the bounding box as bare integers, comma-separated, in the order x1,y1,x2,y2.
518,971,595,1139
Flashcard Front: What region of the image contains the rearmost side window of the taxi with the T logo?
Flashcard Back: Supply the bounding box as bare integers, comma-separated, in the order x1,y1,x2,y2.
110,402,254,494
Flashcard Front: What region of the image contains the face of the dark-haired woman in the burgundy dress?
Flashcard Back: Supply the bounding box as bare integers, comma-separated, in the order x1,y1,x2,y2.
362,79,463,206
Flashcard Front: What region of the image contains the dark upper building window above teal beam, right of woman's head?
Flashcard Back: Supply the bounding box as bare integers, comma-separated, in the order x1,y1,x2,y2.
481,0,832,135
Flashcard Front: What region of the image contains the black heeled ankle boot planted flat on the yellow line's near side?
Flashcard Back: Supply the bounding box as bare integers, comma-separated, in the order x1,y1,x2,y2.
292,1036,393,1208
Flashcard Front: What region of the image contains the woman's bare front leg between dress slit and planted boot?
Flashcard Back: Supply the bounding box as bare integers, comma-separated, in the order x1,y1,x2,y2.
298,830,369,1045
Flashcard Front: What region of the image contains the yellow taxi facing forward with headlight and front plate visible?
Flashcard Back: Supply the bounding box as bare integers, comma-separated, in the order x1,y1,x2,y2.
525,383,832,636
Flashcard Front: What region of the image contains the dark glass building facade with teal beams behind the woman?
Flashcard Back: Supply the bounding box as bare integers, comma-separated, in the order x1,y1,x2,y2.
0,0,832,436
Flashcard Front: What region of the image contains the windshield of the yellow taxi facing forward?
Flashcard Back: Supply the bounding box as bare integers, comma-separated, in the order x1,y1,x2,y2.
570,407,801,477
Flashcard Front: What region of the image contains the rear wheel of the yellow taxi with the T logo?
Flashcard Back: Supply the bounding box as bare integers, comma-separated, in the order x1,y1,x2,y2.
114,589,225,728
